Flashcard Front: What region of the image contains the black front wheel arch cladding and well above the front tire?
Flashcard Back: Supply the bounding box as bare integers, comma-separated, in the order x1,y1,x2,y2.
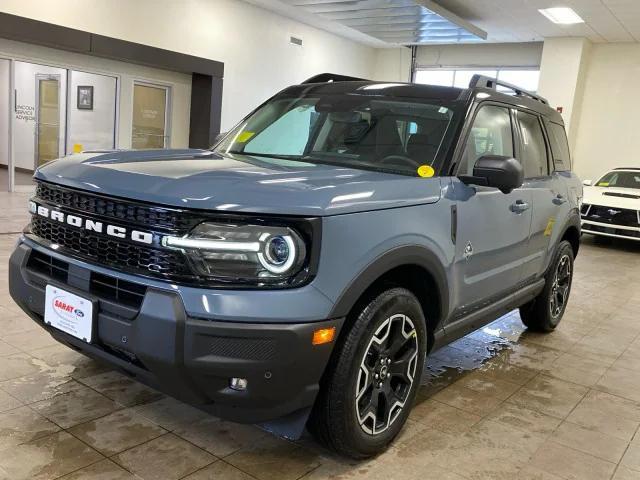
330,245,449,344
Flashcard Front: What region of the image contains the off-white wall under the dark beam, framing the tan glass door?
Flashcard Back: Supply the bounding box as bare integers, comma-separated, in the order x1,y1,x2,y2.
0,39,191,152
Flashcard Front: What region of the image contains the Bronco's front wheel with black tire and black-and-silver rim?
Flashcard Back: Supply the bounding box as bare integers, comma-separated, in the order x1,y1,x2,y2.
308,288,427,459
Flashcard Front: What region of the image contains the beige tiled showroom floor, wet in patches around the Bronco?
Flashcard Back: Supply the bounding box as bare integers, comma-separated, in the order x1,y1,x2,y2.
0,189,640,480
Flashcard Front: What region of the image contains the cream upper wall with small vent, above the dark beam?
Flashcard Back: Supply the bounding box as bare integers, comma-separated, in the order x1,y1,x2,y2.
0,0,375,130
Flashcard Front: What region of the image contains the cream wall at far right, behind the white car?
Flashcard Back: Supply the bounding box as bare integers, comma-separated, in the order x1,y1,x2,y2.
573,43,640,179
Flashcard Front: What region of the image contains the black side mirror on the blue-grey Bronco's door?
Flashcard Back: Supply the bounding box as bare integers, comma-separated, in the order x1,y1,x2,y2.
460,155,524,193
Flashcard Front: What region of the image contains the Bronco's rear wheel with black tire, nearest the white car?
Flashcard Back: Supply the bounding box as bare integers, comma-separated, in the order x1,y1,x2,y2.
520,240,574,332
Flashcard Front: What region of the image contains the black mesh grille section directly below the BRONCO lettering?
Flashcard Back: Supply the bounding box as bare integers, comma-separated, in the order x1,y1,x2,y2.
31,216,191,277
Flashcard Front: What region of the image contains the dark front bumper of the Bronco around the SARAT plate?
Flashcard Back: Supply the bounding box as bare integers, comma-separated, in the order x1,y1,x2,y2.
9,242,343,423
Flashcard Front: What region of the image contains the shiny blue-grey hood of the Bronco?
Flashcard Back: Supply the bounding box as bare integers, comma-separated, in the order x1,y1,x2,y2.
35,150,441,216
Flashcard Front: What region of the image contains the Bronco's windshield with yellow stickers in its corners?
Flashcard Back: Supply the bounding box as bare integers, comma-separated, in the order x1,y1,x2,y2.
216,94,462,176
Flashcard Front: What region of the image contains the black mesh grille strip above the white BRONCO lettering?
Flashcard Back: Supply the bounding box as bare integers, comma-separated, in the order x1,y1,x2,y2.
36,182,198,231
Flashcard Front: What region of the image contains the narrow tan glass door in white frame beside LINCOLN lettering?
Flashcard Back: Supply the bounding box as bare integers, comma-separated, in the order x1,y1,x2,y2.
35,75,60,168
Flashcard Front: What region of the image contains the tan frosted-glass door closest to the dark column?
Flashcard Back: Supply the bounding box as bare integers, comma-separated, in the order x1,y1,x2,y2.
131,83,170,149
